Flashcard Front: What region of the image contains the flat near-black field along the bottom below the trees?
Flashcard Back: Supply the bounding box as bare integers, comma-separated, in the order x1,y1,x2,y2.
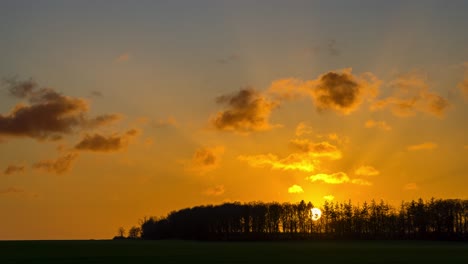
0,240,468,264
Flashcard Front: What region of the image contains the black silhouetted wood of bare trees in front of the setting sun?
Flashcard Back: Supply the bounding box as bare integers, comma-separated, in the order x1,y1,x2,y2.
141,199,468,240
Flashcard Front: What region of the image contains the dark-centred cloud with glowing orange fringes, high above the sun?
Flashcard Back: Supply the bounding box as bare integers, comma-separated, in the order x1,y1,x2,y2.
268,68,381,115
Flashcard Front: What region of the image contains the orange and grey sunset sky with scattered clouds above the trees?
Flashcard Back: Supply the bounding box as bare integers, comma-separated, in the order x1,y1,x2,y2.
0,0,468,240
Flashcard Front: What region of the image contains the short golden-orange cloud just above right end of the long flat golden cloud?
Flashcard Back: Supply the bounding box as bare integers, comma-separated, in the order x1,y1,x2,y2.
290,139,341,160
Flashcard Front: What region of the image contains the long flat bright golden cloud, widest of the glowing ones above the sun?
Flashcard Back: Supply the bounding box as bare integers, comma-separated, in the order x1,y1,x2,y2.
238,153,319,172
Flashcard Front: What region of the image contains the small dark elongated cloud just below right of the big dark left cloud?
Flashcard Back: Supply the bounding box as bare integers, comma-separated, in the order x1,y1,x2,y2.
74,129,138,152
